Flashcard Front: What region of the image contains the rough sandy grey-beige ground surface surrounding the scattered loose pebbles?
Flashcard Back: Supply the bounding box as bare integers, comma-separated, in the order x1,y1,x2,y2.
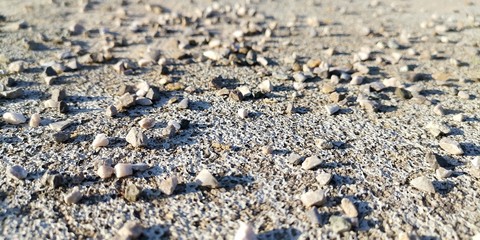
0,0,480,239
